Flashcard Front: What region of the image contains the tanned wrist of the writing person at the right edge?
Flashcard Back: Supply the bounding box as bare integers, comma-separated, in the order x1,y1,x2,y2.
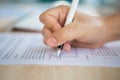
102,16,120,41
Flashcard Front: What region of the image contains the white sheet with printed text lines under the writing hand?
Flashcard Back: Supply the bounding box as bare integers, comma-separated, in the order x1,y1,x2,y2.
0,33,120,67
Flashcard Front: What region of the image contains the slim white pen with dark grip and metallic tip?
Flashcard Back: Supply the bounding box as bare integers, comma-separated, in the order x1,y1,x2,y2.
57,0,79,56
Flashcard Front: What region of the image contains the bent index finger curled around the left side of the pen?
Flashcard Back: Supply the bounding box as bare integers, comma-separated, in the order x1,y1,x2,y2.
40,6,69,31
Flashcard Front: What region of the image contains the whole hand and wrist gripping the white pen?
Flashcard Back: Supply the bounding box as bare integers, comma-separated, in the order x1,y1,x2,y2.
40,6,120,50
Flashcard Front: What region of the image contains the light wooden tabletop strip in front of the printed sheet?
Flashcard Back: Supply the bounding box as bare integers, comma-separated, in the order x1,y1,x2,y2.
0,3,120,80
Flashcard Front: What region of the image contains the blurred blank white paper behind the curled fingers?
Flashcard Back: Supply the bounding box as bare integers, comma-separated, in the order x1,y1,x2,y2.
14,11,44,31
